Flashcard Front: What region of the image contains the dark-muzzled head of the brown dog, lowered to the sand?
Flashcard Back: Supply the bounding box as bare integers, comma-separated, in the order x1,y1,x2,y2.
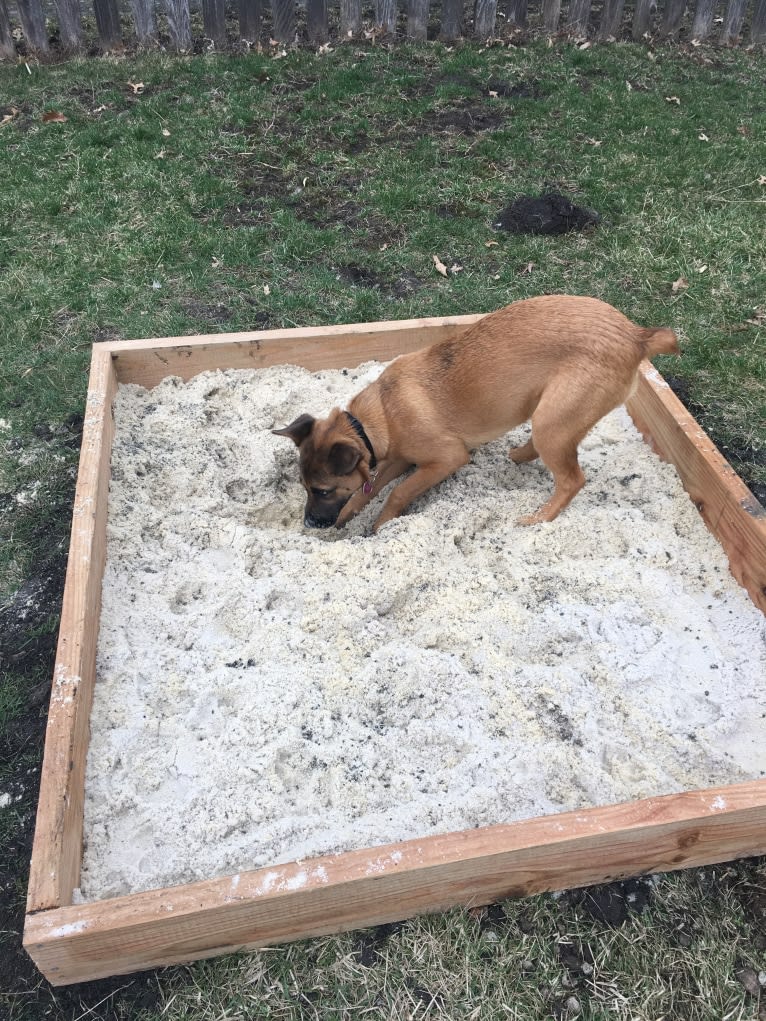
272,409,370,528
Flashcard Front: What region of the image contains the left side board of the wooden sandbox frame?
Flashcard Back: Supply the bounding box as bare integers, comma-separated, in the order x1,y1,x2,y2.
27,352,116,911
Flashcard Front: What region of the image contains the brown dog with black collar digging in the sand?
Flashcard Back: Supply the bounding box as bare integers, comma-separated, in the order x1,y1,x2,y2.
274,295,678,531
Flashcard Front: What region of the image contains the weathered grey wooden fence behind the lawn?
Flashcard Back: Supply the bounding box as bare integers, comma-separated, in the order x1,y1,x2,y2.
0,0,766,58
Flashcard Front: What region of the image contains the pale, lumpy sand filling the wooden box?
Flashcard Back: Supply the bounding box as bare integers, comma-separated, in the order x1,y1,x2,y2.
81,364,766,900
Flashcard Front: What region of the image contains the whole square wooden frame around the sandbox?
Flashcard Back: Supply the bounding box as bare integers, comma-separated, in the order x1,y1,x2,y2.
23,315,766,984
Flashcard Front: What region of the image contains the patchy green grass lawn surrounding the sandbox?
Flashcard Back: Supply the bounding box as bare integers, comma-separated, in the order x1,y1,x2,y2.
0,33,766,1021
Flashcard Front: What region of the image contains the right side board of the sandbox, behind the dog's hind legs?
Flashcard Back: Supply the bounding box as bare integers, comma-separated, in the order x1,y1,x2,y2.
627,362,766,613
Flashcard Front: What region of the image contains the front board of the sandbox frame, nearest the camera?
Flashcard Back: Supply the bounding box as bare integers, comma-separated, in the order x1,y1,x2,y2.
25,781,766,984
